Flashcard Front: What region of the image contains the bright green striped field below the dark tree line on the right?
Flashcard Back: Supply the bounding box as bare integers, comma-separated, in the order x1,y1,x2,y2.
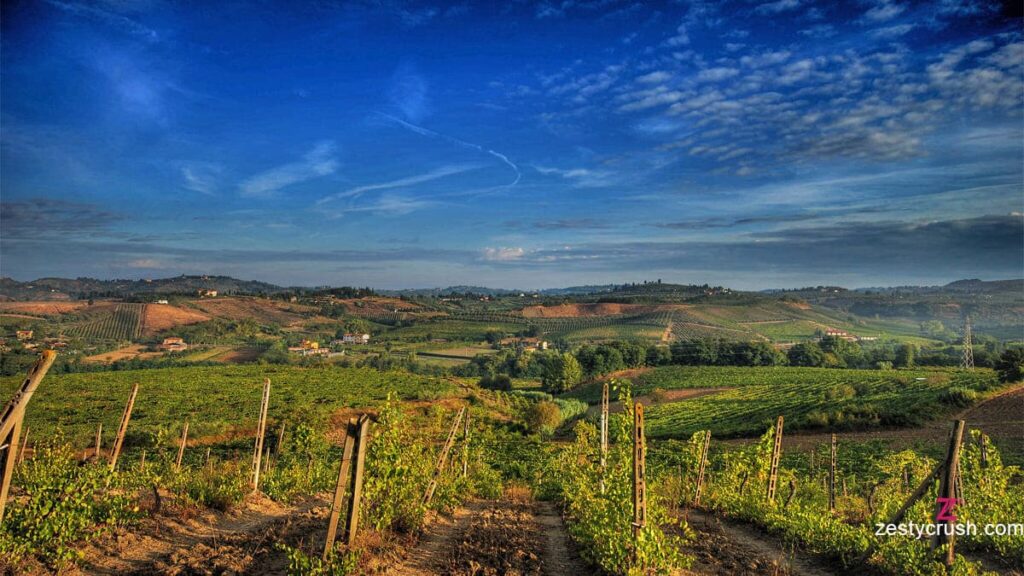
569,366,999,438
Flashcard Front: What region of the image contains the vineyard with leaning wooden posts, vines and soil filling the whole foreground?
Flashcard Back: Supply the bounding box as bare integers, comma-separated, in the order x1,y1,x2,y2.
0,354,1024,576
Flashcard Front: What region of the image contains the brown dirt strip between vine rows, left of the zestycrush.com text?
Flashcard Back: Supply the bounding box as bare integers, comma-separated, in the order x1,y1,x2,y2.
683,509,849,576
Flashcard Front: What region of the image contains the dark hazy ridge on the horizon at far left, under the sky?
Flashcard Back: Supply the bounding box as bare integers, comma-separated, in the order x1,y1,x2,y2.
0,276,285,300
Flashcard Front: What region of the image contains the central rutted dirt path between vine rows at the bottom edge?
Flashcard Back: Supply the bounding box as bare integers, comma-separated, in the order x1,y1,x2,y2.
386,500,595,576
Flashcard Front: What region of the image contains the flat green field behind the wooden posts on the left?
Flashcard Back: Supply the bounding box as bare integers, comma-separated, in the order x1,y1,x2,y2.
0,365,455,447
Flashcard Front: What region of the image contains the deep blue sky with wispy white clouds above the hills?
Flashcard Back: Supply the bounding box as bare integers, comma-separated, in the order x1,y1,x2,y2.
0,0,1024,288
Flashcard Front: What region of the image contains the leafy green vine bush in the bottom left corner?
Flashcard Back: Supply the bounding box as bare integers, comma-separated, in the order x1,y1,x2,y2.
0,443,140,569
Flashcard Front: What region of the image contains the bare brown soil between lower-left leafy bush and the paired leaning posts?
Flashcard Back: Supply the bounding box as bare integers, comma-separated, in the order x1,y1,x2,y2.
68,487,329,575
